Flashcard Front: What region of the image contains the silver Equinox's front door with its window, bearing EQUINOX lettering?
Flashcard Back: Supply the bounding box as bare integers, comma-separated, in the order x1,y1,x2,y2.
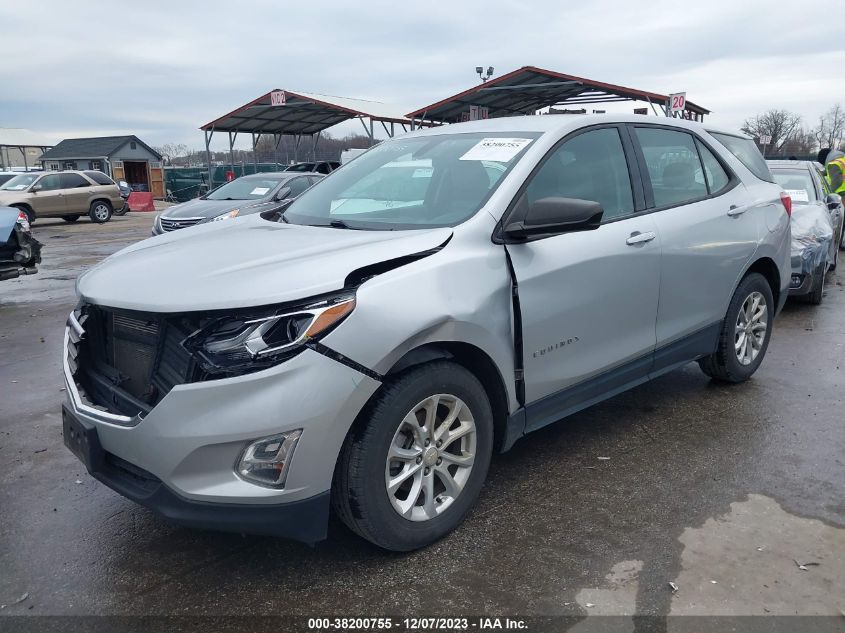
506,126,660,430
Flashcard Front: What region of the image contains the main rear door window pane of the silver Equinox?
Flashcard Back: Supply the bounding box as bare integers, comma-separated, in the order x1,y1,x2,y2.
636,127,707,208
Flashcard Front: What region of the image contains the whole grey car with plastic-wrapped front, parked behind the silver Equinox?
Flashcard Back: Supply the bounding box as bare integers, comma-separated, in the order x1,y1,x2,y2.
768,160,845,305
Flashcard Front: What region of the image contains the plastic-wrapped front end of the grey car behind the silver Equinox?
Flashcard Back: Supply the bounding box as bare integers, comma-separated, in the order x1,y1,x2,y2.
789,205,834,295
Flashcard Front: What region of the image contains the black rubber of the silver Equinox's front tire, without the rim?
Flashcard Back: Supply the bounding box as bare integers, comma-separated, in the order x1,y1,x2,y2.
332,361,493,552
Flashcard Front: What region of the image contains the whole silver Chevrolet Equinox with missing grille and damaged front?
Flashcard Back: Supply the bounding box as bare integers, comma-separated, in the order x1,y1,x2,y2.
63,115,791,551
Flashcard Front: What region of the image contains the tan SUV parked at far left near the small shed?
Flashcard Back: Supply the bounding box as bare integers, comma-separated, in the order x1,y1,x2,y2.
0,171,123,224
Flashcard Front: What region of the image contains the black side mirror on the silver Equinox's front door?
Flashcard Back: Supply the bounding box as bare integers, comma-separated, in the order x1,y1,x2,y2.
505,198,604,239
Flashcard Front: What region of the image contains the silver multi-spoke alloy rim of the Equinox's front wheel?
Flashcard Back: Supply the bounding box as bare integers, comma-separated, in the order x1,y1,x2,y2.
384,394,477,521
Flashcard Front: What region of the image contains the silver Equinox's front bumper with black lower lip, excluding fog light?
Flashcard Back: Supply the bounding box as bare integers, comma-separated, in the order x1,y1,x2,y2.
64,320,379,542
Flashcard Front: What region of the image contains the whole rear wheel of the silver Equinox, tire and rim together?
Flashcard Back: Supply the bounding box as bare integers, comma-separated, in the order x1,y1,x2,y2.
698,273,775,383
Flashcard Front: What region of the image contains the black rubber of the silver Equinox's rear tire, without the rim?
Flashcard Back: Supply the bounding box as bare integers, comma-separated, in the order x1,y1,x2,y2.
698,273,775,383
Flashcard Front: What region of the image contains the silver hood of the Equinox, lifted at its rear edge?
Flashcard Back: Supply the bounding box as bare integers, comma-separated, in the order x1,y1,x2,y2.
77,215,452,312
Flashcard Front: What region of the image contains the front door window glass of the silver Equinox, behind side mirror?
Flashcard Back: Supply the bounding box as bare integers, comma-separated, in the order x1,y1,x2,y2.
526,128,634,221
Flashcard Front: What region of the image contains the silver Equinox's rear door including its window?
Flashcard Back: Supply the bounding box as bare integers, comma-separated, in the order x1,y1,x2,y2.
633,125,765,360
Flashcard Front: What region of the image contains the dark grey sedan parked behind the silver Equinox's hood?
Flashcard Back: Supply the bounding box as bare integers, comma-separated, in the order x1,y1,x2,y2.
153,172,323,235
